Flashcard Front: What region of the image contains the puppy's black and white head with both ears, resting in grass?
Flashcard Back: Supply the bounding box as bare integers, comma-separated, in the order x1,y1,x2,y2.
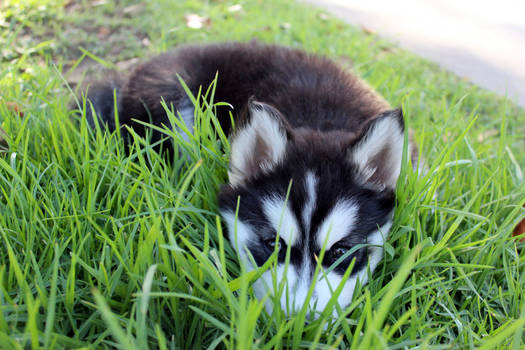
219,103,403,317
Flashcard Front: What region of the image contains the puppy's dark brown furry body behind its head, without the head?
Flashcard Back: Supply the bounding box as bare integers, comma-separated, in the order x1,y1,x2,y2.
88,44,390,146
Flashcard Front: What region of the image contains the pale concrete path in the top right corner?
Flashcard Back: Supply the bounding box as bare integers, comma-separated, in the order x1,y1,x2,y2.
303,0,525,107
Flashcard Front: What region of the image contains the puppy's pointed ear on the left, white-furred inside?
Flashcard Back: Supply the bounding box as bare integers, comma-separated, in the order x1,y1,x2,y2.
228,100,288,186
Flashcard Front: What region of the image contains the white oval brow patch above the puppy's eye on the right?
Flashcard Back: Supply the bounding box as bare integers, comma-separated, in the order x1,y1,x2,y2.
316,200,359,251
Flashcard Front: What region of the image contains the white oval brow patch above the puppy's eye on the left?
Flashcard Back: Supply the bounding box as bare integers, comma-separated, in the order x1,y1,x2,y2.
262,197,299,246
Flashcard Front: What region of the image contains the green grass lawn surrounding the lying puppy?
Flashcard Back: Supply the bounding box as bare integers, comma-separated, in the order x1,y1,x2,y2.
0,0,525,350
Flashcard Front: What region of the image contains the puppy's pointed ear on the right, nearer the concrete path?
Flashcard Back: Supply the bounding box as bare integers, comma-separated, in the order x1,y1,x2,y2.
349,109,405,190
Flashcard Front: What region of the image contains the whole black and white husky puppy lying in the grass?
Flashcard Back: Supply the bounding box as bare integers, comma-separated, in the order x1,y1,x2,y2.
81,43,410,313
